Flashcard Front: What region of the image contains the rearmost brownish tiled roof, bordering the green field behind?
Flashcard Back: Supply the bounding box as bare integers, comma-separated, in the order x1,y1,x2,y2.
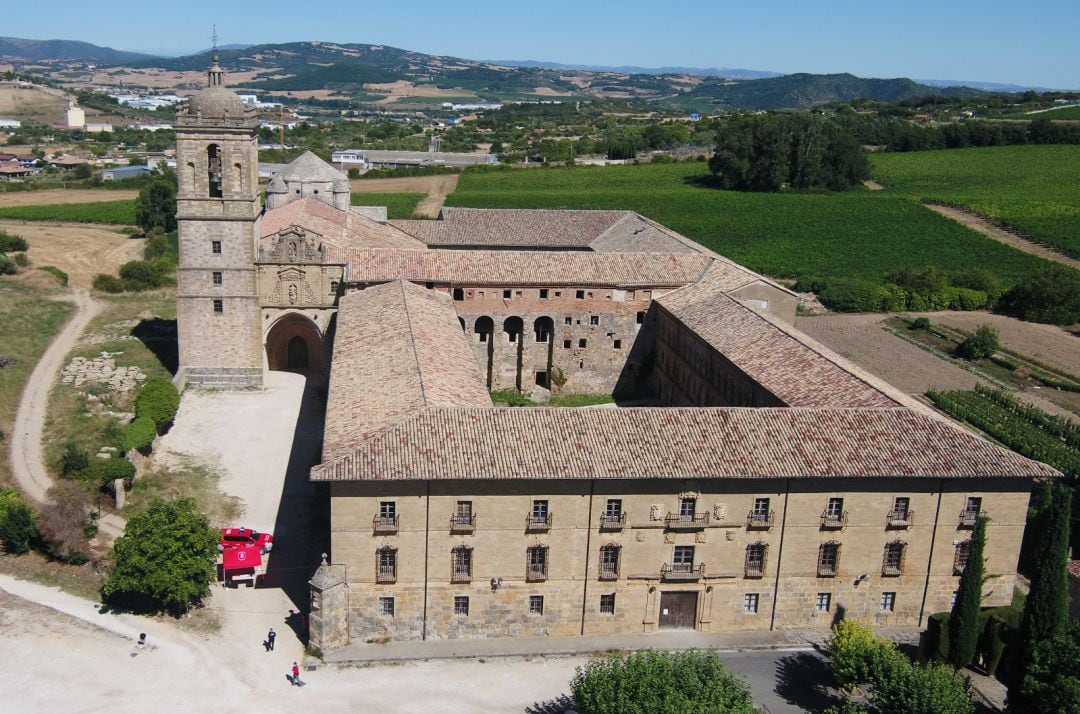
391,208,631,250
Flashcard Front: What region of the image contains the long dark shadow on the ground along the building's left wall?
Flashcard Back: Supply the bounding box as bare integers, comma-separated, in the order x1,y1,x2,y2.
261,369,329,643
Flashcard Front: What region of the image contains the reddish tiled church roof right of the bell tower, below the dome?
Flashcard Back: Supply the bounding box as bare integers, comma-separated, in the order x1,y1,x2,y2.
261,198,426,251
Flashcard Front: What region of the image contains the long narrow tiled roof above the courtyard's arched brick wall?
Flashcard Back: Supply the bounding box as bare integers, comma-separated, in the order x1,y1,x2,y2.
326,248,711,287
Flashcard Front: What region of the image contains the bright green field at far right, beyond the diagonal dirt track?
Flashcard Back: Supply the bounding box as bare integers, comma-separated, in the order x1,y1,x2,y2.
870,143,1080,257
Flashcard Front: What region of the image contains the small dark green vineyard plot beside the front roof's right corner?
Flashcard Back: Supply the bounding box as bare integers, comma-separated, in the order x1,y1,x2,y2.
927,386,1080,476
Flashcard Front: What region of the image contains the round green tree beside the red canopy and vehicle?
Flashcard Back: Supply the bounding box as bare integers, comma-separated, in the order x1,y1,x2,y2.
102,499,217,615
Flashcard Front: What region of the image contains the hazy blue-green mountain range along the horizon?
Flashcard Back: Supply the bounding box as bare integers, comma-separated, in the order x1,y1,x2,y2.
0,38,1025,111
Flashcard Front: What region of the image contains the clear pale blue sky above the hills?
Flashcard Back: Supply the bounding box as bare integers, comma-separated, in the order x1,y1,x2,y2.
8,0,1080,89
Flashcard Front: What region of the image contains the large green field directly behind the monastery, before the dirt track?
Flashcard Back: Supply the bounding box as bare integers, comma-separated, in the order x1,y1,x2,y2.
447,163,1044,285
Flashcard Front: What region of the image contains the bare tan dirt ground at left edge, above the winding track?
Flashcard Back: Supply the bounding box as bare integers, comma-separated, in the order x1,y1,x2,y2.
0,220,145,289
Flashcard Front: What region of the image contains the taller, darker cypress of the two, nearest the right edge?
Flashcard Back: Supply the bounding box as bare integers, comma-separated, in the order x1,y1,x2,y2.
1009,475,1072,706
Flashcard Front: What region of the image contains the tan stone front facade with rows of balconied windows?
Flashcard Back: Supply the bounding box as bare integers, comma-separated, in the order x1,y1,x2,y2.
330,479,1030,641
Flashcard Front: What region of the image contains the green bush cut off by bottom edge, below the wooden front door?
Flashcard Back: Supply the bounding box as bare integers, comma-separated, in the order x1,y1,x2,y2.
570,649,755,714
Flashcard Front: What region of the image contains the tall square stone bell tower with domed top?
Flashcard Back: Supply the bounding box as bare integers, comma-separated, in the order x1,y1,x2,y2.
176,55,262,389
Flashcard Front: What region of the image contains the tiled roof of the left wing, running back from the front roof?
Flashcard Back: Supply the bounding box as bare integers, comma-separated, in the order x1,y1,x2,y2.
323,281,491,458
